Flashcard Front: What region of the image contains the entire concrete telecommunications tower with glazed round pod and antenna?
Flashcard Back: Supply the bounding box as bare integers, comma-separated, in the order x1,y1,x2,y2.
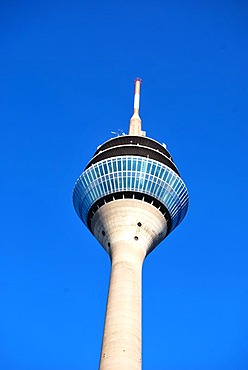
73,79,188,370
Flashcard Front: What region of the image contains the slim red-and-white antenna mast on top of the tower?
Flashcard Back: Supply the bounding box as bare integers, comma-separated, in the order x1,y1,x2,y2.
128,77,145,136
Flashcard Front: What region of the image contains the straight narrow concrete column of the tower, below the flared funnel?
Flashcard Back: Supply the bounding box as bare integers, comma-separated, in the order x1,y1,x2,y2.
100,241,146,370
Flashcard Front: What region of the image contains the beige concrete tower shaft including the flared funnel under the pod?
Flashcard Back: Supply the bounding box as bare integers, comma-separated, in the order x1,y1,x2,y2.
92,199,167,370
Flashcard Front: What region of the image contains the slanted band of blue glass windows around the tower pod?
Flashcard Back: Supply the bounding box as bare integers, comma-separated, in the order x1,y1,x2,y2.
73,156,188,229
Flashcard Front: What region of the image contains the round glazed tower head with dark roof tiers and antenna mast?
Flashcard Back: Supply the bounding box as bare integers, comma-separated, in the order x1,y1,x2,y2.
73,79,189,241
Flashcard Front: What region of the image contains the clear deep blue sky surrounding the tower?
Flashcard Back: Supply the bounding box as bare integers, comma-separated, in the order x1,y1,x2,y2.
0,0,248,370
